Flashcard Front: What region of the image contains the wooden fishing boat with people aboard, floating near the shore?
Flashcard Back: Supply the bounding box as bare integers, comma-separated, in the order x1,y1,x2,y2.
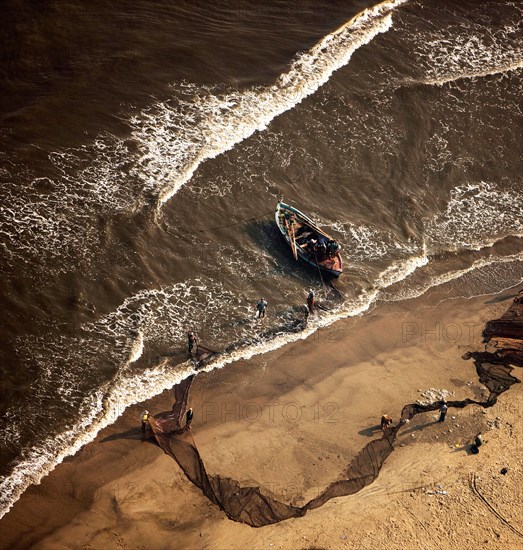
274,201,343,277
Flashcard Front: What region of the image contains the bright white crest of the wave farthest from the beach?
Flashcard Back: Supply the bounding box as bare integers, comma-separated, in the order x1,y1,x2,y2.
133,0,406,204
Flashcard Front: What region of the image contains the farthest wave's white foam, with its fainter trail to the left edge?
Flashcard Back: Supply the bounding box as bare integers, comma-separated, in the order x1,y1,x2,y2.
0,0,407,268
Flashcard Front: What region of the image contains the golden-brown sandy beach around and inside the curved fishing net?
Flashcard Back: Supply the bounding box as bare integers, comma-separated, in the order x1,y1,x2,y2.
0,290,523,550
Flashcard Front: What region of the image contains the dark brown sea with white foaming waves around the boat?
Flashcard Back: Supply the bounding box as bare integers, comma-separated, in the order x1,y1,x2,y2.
0,0,523,516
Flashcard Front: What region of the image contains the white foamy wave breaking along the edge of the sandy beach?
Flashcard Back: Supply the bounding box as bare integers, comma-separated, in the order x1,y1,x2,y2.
0,243,522,517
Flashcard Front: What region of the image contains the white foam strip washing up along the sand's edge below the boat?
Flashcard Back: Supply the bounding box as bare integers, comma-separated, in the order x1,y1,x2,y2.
0,243,523,517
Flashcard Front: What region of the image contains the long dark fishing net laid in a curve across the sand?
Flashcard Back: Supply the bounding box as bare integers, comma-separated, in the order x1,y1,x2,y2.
151,302,523,527
